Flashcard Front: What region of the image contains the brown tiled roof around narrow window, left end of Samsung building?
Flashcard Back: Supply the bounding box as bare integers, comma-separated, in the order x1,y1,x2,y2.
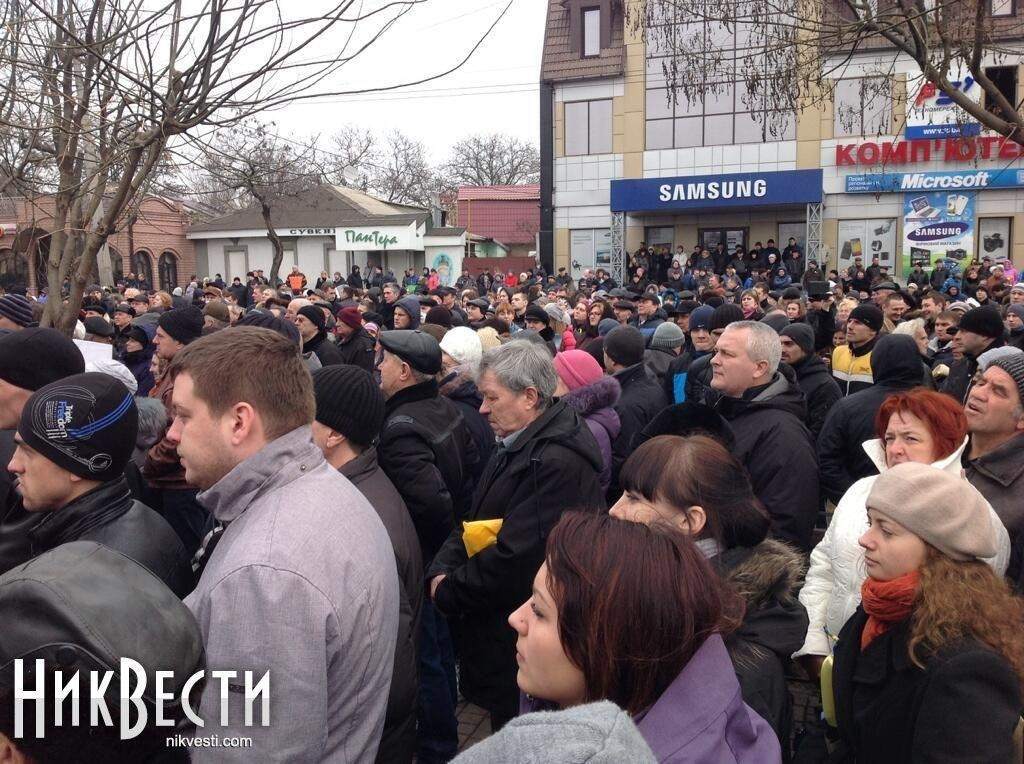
541,0,626,82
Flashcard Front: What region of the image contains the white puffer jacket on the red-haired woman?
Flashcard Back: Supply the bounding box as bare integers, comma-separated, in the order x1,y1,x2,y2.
793,438,1010,657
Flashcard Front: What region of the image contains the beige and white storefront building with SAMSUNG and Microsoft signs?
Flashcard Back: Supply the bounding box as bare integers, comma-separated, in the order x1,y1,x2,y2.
540,0,1024,275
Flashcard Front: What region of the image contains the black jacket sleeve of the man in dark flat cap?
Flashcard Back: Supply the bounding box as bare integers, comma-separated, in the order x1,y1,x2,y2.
377,424,455,555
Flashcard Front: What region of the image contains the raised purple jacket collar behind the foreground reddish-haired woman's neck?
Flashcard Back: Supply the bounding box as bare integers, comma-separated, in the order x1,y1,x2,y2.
637,634,739,748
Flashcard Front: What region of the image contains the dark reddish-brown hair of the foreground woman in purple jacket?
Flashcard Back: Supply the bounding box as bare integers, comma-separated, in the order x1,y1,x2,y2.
546,512,738,715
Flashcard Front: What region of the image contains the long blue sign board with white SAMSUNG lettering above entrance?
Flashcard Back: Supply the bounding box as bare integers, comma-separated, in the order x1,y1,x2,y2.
611,170,821,212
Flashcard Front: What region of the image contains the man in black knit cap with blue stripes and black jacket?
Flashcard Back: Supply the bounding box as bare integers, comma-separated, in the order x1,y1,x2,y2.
9,372,194,597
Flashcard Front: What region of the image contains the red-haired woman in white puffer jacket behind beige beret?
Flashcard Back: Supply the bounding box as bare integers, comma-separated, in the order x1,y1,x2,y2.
794,387,1010,675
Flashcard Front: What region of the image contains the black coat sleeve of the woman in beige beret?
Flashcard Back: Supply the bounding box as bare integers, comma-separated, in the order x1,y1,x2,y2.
911,649,1021,764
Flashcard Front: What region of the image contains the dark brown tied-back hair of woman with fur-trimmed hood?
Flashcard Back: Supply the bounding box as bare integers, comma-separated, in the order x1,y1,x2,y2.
618,435,770,549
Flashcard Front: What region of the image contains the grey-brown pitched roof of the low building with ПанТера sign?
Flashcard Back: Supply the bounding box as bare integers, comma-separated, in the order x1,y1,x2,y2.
188,185,428,234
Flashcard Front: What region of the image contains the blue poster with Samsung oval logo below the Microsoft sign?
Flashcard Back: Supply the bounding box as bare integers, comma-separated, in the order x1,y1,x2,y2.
903,190,977,273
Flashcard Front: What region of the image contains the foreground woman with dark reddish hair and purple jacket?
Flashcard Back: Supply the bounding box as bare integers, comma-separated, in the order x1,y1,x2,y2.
509,512,780,764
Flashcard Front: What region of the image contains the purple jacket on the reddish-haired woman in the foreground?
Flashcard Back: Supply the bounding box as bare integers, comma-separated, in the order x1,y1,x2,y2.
634,634,782,764
